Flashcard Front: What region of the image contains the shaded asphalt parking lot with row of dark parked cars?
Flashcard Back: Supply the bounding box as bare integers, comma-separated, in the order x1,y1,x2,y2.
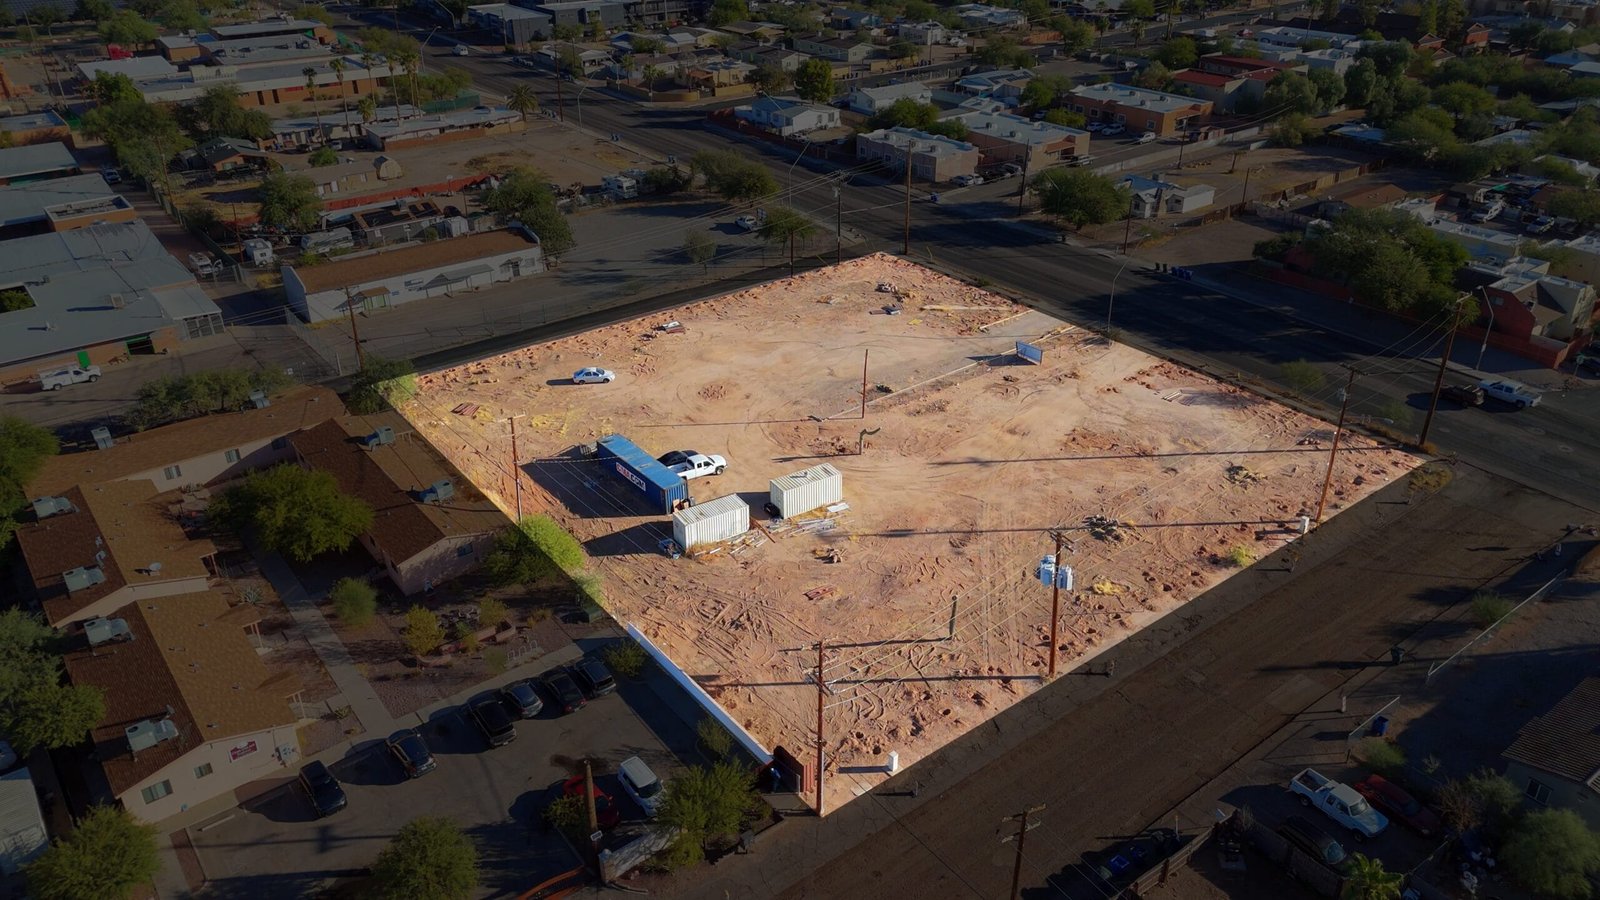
190,643,690,898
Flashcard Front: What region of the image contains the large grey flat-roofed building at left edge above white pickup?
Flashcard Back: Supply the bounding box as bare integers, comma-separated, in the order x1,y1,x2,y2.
0,221,222,381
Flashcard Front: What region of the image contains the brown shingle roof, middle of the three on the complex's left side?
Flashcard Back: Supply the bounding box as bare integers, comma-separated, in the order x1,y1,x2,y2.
18,480,216,625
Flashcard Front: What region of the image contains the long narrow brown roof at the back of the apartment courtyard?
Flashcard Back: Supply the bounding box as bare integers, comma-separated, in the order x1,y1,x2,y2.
29,388,346,496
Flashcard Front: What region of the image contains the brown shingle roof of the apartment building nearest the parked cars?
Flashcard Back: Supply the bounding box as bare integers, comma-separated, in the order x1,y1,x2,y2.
66,593,299,794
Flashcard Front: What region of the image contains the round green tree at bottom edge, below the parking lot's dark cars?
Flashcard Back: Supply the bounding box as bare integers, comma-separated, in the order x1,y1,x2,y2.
373,817,478,900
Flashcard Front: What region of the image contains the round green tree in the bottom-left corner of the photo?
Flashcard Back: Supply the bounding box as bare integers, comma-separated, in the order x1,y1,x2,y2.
26,806,162,900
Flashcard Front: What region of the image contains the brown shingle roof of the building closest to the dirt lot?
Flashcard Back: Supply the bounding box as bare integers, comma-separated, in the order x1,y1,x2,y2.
290,412,510,565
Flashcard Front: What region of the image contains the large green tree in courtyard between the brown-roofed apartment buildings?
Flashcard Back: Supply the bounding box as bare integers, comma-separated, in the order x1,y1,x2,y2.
213,463,373,562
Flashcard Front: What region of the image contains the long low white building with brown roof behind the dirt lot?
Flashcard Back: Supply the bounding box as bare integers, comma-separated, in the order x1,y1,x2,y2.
283,229,544,322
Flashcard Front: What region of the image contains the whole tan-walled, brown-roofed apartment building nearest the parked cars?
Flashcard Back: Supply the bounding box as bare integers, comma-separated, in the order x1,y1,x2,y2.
66,591,301,822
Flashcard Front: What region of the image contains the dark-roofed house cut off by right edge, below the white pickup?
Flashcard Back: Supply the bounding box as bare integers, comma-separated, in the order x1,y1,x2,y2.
1501,674,1600,828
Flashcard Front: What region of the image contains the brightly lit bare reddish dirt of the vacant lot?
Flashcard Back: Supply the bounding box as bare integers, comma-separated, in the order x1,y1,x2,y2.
396,256,1414,806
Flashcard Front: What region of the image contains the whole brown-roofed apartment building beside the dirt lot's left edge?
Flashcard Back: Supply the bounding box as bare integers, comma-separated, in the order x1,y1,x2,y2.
290,412,510,596
